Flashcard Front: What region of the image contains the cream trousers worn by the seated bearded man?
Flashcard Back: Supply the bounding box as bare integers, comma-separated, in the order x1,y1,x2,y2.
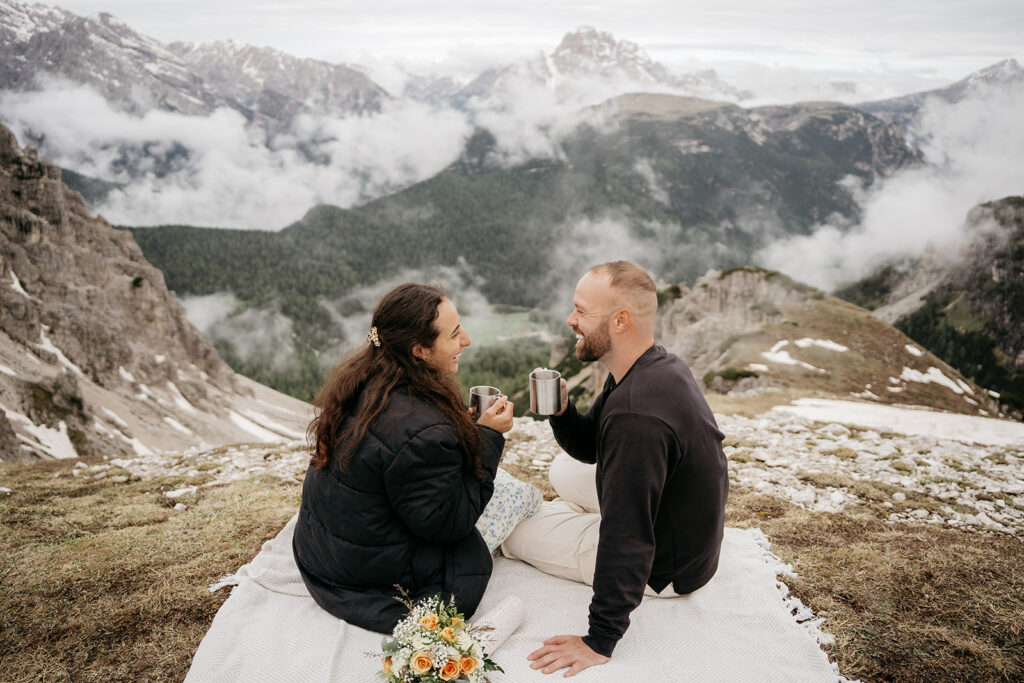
502,454,676,598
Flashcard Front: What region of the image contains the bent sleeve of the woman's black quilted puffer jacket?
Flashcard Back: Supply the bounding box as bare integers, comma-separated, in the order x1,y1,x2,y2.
384,424,505,542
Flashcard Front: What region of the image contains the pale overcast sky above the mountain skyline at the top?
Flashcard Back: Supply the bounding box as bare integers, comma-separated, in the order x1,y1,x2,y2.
45,0,1024,85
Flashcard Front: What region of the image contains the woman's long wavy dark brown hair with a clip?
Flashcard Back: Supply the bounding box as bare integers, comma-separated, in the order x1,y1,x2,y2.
307,283,486,480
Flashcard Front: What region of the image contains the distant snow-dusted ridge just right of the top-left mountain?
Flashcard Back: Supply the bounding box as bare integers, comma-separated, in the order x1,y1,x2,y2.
168,40,387,117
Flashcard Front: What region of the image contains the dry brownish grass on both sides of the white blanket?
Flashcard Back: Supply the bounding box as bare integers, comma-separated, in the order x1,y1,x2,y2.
0,450,1024,681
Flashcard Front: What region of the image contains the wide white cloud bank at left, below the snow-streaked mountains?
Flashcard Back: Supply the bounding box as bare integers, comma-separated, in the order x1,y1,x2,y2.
0,76,471,230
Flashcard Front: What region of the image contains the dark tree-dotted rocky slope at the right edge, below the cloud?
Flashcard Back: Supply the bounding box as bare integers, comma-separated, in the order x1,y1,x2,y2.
837,197,1024,414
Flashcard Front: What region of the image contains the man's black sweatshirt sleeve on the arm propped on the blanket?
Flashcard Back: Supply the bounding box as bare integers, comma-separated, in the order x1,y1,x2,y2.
584,413,678,656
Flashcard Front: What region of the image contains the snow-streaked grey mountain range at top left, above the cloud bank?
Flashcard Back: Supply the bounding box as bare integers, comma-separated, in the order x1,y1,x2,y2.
0,0,387,125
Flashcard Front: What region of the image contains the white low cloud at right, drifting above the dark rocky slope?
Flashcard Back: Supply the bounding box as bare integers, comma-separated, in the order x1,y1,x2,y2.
757,80,1024,290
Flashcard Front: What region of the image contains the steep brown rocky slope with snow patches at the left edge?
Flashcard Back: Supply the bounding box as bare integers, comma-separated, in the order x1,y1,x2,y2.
0,127,306,460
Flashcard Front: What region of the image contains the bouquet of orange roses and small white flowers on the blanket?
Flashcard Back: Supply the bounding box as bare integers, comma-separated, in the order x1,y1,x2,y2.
380,593,504,683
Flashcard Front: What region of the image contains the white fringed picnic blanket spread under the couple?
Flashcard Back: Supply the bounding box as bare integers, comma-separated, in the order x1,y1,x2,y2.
185,518,838,683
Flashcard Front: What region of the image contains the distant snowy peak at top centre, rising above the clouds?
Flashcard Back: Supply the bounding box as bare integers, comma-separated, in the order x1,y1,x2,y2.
453,26,751,104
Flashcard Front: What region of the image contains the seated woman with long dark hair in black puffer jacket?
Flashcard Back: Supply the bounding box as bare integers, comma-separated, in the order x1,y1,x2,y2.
292,284,513,633
